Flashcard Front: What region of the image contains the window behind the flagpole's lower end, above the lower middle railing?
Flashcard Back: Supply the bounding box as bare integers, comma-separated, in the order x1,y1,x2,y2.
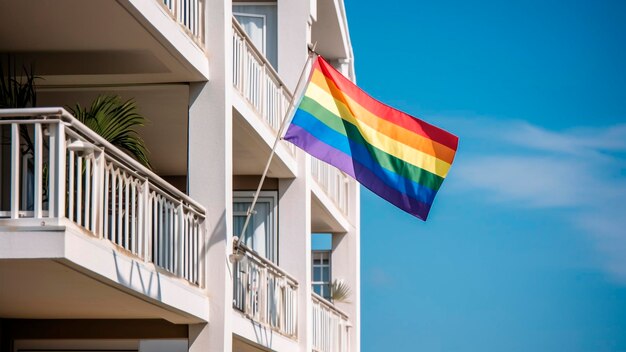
233,191,278,263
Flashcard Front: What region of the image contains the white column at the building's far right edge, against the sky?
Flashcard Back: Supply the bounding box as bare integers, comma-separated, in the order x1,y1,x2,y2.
331,182,361,352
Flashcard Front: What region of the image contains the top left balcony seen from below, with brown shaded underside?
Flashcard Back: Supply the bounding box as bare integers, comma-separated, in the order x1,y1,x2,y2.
0,0,209,86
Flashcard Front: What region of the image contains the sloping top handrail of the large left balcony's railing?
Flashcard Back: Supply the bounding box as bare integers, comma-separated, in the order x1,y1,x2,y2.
0,107,206,215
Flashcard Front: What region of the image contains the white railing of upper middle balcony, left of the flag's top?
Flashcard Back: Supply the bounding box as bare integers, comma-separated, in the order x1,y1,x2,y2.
233,17,295,155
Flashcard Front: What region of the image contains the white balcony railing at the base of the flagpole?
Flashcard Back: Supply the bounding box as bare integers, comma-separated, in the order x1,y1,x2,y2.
233,244,298,338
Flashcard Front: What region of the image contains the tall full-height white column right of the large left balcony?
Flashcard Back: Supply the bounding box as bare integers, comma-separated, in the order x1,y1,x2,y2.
187,0,233,352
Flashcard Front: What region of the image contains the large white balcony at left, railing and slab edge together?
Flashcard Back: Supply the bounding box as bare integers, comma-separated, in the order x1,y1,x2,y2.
0,108,208,322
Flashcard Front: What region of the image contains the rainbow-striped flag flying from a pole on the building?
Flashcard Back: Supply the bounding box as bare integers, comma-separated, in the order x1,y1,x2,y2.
284,57,458,220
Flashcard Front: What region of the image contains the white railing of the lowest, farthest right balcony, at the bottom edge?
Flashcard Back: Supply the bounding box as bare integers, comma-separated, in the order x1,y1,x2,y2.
311,293,351,352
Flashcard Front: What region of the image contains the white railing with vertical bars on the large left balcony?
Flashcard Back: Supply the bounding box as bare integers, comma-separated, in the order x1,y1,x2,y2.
0,108,205,286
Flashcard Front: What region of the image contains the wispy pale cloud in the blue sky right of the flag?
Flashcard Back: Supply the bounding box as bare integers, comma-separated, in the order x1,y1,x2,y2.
442,118,626,284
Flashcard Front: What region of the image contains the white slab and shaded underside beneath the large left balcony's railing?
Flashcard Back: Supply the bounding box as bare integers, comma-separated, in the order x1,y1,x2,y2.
0,221,209,324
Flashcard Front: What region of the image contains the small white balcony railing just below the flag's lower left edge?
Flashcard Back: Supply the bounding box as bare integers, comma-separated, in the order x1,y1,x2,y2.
311,157,351,215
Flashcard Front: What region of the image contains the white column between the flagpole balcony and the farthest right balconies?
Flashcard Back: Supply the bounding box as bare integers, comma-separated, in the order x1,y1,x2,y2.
278,151,312,351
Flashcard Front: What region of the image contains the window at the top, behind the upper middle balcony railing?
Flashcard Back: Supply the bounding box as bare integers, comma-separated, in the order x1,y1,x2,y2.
233,3,278,69
